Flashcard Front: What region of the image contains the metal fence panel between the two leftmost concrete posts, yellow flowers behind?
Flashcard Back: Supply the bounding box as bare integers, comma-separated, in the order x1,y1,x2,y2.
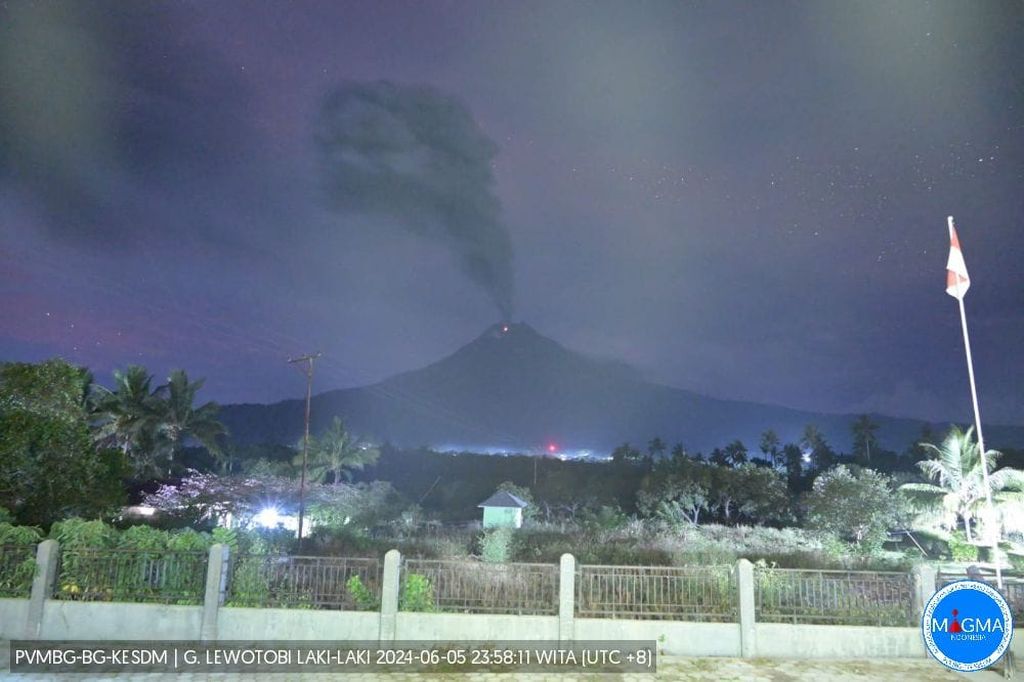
53,549,208,604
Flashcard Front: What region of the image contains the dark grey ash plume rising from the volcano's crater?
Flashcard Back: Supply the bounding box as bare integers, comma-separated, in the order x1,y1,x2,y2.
315,82,513,319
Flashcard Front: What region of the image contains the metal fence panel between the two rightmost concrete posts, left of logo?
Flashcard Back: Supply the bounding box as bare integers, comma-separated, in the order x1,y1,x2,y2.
754,568,918,626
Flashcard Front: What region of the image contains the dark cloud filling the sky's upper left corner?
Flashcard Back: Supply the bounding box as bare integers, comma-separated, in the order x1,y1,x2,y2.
0,2,251,242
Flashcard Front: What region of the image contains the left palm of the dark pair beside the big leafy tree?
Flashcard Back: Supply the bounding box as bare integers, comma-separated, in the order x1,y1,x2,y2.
91,365,160,471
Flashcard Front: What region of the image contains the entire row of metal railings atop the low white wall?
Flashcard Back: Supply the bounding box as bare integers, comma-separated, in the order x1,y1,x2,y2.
0,541,983,627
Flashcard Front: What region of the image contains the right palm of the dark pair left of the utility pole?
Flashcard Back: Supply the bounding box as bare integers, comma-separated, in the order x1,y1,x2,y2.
157,370,227,475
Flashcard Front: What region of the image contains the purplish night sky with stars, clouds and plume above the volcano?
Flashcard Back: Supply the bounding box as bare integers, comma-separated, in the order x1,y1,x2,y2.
0,0,1024,424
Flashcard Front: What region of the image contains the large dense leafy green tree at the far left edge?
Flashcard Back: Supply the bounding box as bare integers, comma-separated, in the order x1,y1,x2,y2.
0,359,124,525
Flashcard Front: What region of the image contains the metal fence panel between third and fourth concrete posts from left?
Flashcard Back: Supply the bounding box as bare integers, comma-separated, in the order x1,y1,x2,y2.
398,559,558,615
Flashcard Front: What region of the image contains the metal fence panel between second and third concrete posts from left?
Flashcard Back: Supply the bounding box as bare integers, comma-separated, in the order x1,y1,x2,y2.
224,554,382,610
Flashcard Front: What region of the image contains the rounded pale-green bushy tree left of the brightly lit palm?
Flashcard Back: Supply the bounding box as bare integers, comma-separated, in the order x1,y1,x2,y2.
806,464,902,552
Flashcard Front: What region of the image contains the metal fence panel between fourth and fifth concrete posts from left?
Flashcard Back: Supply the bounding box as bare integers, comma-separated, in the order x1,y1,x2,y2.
575,565,738,623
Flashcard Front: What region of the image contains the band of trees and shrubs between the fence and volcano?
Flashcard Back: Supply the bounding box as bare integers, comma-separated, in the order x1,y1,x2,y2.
0,360,1024,566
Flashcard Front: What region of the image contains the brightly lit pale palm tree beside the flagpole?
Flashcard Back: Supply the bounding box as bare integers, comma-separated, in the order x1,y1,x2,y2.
900,426,1024,542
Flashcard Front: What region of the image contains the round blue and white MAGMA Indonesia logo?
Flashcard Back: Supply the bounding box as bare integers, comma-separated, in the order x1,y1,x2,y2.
921,581,1014,673
